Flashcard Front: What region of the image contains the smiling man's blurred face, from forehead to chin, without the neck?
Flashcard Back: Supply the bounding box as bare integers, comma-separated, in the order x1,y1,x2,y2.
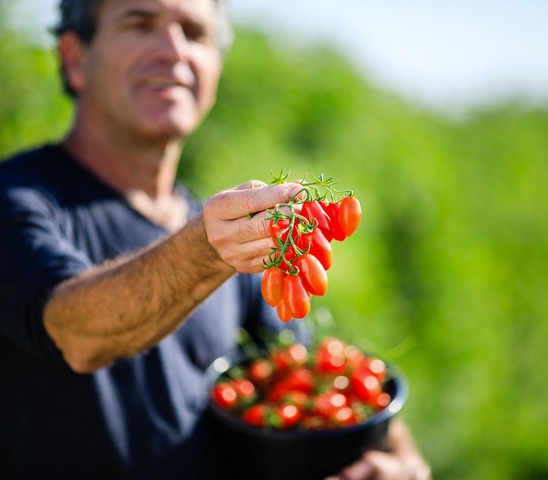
73,0,221,139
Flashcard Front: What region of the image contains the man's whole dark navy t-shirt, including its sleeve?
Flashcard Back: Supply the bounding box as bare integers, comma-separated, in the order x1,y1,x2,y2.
0,145,292,480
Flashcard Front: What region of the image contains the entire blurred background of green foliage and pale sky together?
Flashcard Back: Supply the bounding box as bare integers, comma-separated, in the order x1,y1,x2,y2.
0,0,548,480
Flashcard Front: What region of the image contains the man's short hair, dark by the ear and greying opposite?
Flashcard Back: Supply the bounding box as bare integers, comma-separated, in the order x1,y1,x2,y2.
52,0,232,96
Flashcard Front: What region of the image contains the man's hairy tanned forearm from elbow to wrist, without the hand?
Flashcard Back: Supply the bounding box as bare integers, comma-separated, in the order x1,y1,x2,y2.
44,216,234,373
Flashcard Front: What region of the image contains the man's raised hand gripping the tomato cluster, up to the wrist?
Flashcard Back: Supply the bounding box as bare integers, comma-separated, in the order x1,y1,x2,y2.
203,180,302,273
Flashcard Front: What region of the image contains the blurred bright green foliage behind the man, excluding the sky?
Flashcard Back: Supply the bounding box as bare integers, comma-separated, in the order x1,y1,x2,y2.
0,20,548,480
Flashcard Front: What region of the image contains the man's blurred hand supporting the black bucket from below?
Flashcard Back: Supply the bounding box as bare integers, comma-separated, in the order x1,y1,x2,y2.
326,421,431,480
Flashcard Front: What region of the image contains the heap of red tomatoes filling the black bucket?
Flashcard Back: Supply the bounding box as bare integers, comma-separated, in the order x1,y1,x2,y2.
212,337,391,430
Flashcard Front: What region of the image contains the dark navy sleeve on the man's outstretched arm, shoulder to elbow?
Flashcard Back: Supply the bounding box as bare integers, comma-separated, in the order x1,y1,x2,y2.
0,173,91,359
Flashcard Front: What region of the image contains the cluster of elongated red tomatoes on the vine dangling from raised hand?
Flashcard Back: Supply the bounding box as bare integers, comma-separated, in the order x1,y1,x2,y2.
261,196,362,322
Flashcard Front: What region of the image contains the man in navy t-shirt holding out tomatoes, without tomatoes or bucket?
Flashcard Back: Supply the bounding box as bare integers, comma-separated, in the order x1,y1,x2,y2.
0,0,430,480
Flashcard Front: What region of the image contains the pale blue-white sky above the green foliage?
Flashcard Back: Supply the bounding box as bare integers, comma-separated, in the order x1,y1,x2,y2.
8,0,548,112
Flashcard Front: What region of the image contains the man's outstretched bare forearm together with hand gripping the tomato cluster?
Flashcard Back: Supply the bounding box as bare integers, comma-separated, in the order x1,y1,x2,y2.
44,184,299,373
